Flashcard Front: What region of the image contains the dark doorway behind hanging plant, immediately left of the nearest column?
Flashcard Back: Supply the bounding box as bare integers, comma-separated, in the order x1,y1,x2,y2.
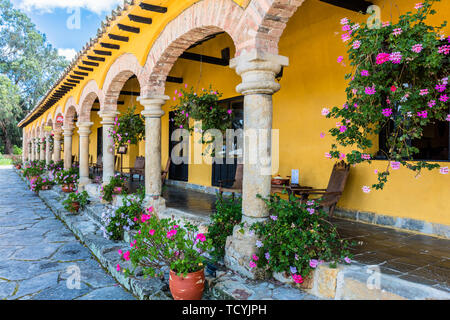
211,96,244,188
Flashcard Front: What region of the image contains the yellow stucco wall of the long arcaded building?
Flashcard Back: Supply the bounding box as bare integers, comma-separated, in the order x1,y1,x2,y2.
27,0,450,225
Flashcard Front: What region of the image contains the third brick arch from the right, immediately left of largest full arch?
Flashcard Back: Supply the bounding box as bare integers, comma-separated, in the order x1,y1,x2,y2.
100,53,145,111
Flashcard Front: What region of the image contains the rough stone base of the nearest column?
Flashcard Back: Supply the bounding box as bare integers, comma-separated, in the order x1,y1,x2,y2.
224,225,267,280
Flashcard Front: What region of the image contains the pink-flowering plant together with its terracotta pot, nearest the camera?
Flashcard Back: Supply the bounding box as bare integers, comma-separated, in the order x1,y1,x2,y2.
117,209,212,300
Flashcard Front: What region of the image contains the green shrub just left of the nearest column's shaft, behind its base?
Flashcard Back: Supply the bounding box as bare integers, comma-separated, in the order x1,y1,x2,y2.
208,196,242,260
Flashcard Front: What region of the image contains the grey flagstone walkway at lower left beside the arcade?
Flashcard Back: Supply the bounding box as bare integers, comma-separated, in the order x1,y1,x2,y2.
0,166,135,300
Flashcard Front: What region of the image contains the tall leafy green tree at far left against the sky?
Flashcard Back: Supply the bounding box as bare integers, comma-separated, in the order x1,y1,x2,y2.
0,0,68,153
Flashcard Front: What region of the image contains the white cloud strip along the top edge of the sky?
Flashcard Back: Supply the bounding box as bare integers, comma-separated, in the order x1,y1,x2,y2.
13,0,123,14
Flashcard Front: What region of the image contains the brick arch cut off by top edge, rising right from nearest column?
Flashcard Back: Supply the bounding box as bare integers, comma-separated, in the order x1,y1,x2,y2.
236,0,305,56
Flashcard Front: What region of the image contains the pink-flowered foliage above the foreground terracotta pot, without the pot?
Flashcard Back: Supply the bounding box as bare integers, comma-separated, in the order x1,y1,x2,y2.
117,214,211,277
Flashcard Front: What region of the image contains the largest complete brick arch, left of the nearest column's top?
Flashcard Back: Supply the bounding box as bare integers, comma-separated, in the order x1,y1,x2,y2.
141,0,244,96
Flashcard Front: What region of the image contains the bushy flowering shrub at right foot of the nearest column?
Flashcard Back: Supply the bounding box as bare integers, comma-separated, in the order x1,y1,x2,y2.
249,195,351,283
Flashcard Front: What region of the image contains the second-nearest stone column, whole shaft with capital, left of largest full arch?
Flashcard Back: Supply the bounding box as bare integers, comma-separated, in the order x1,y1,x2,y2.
138,95,170,213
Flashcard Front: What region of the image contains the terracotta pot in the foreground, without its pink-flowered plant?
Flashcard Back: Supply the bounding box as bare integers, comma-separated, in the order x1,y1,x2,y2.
169,269,205,300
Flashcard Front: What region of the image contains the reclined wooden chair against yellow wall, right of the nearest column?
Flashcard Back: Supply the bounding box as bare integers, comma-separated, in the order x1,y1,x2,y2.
291,161,350,217
